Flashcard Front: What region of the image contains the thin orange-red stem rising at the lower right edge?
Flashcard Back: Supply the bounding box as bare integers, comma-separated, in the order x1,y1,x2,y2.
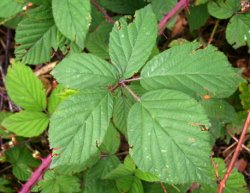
218,110,250,193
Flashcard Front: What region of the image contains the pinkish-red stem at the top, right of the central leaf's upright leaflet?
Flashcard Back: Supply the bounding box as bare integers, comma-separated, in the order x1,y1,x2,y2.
158,0,189,35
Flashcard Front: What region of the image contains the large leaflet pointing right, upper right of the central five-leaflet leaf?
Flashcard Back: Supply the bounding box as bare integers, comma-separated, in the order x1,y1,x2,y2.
141,42,244,98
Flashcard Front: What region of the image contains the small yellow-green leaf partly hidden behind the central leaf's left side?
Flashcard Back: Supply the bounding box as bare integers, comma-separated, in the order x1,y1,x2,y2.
48,84,63,114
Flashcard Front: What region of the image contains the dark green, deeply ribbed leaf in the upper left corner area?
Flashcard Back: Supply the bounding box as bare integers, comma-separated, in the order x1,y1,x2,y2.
15,6,57,64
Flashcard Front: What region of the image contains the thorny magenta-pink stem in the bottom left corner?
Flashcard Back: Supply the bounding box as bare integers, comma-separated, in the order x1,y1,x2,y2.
18,154,52,193
